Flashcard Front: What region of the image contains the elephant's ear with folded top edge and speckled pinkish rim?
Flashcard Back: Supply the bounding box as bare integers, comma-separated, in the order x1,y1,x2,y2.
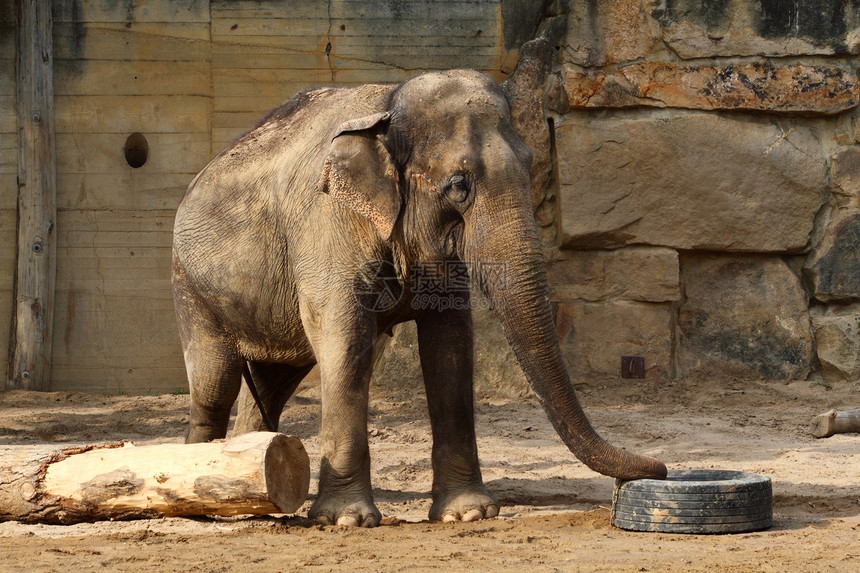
321,112,400,239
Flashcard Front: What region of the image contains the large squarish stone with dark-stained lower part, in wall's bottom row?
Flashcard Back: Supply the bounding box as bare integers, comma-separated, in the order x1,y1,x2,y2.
677,255,813,379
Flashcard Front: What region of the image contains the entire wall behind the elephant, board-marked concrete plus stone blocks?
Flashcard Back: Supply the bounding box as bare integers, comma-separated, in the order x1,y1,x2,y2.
5,0,860,393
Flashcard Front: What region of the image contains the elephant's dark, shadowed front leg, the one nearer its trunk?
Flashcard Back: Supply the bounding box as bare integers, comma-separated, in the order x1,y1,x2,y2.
418,302,499,521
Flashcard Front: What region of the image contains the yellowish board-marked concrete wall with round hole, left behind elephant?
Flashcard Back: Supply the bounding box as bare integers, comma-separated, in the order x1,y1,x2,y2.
0,0,539,393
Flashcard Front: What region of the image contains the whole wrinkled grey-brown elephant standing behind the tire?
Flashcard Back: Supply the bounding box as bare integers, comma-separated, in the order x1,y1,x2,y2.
173,71,666,526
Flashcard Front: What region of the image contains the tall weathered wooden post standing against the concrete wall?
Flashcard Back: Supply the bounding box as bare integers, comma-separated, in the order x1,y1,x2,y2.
6,0,57,390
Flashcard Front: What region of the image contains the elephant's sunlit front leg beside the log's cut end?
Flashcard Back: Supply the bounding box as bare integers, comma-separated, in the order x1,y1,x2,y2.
309,308,382,527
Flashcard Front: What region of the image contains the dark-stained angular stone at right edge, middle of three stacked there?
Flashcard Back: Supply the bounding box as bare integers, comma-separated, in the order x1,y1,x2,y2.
804,213,860,302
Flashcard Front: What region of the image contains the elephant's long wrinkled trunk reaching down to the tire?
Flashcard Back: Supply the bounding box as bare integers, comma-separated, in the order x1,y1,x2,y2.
467,200,666,479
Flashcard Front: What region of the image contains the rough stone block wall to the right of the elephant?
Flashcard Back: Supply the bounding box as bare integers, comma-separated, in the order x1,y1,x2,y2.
542,0,860,380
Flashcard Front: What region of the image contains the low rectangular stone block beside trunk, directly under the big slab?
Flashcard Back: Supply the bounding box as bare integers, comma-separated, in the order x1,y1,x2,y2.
547,247,681,302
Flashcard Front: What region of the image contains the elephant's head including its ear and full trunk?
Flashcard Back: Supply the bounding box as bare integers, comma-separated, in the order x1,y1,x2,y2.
323,71,666,479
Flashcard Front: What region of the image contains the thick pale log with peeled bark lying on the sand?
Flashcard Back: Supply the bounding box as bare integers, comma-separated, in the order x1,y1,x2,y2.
0,432,310,523
